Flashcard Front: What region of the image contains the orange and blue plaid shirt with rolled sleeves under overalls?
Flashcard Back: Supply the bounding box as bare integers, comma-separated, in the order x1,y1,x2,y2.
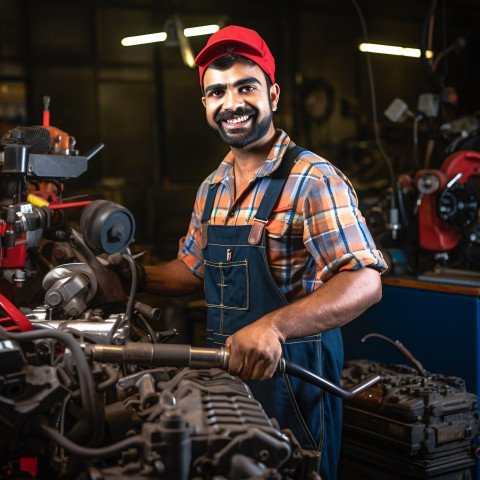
178,130,386,301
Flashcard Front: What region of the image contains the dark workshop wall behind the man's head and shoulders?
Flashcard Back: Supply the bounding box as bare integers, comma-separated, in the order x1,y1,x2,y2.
0,0,480,262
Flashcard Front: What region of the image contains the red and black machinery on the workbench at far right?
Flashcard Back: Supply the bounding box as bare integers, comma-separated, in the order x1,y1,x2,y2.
366,0,480,285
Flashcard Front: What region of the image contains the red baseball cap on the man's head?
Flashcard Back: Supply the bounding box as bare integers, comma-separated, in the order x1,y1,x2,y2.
195,25,275,88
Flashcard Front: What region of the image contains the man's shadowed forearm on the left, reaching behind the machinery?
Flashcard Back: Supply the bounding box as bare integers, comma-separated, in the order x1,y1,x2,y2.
145,259,203,296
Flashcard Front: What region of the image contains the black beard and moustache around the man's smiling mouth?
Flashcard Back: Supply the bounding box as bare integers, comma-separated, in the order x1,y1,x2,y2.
212,108,273,148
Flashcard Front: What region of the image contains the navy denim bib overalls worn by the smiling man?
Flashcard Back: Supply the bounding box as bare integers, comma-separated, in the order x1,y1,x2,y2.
202,147,343,480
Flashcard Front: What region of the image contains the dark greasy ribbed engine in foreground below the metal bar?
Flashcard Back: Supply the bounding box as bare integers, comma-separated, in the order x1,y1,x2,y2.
0,329,319,480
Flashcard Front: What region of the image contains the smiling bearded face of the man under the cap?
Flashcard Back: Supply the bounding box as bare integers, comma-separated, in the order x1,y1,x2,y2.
202,62,279,148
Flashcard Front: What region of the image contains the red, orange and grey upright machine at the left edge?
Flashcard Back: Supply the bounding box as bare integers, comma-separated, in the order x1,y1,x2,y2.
0,97,103,303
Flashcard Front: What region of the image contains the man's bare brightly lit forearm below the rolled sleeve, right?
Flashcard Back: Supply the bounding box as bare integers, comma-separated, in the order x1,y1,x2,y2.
259,268,382,342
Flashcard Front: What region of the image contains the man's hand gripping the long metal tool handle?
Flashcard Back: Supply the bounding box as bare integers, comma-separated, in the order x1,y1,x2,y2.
225,316,284,380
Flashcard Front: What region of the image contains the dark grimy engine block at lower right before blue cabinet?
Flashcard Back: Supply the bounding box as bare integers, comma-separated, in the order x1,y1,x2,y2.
340,360,480,480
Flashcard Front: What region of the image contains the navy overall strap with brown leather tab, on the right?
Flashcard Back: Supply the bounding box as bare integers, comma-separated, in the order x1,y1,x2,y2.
248,145,305,245
